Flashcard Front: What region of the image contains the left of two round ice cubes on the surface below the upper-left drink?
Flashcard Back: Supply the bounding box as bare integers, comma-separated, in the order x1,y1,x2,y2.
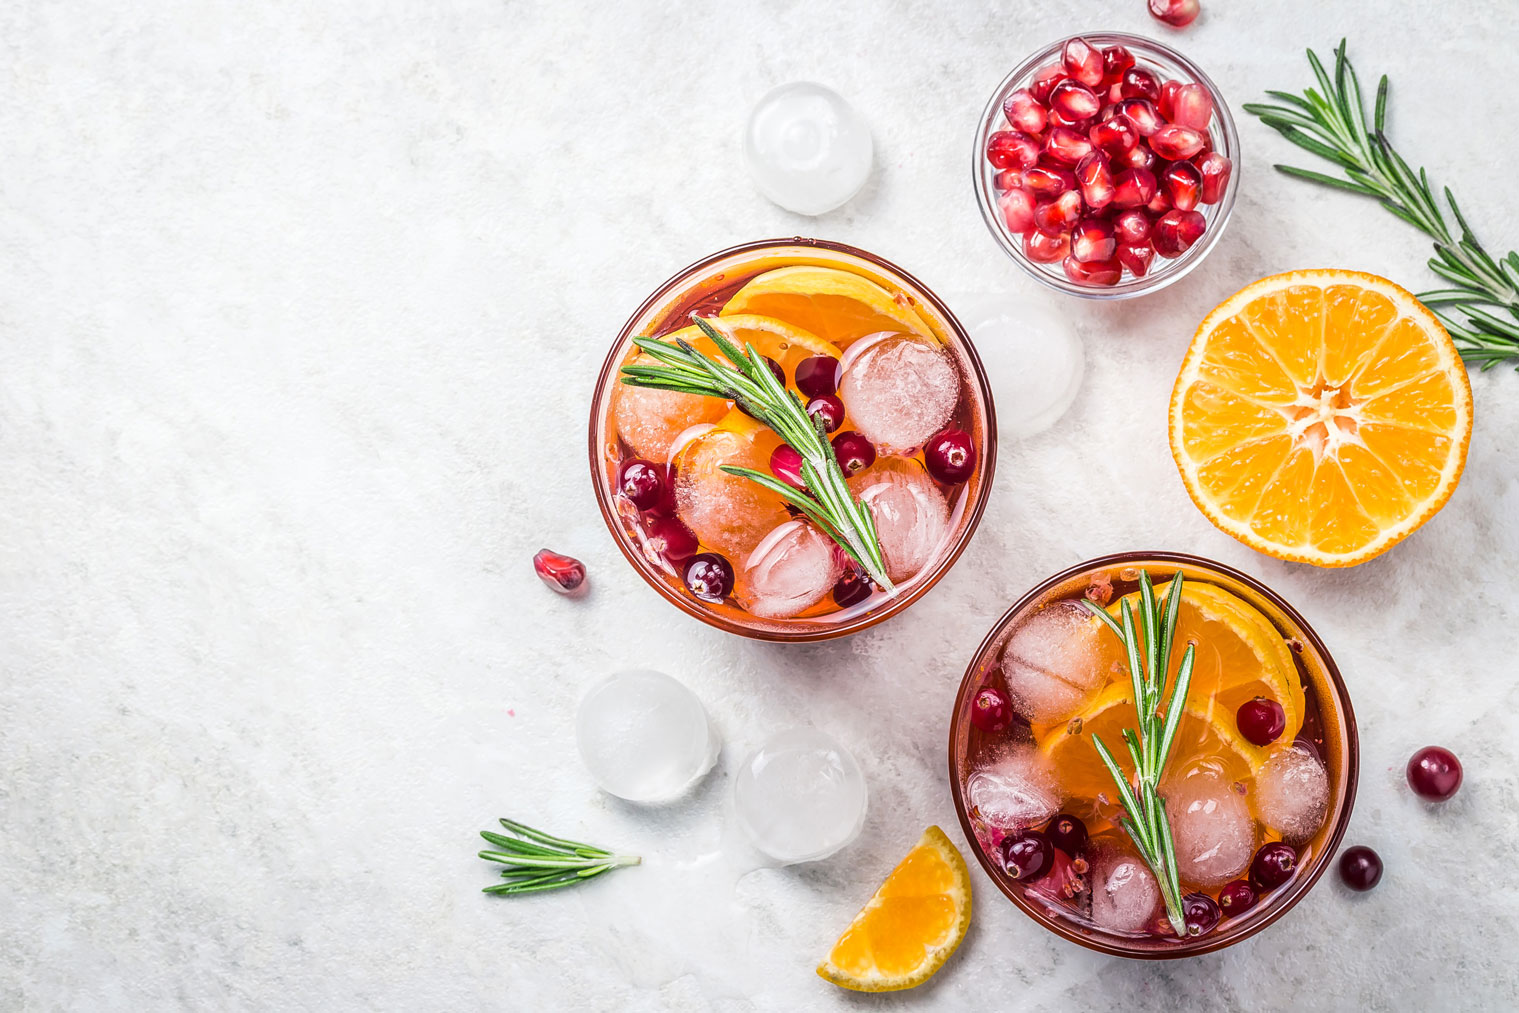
576,668,718,802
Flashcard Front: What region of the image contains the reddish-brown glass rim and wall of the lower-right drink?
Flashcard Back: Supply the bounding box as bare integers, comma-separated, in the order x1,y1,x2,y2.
949,553,1360,960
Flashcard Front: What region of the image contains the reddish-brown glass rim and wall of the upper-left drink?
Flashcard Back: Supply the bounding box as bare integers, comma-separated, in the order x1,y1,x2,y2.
589,238,996,642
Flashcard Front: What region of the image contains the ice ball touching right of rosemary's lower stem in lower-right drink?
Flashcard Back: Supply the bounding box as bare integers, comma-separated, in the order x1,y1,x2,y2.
1162,767,1255,887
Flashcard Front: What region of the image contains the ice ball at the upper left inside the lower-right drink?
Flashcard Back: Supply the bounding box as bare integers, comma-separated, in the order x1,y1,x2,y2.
1003,601,1118,724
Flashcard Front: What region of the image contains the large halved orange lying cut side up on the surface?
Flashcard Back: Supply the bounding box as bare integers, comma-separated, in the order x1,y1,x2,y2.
1171,270,1472,566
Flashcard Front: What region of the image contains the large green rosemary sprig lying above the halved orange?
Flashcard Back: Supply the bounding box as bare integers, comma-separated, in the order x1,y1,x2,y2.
1244,39,1519,369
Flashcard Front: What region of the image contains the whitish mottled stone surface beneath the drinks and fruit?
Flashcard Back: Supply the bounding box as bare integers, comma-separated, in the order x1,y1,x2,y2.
0,0,1519,1011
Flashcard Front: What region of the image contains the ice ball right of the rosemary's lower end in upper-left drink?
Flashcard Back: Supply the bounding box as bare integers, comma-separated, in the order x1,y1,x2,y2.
849,457,949,582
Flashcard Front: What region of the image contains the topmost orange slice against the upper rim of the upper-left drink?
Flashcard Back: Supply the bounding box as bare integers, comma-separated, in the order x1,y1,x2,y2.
720,264,939,348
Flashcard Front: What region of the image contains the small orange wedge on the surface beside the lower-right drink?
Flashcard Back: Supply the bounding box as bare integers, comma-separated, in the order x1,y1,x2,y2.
817,826,971,992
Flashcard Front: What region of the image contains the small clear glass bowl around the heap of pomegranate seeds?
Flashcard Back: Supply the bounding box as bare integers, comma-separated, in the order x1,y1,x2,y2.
971,32,1240,299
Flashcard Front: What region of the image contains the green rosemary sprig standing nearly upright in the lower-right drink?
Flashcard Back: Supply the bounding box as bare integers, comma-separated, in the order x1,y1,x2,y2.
1082,570,1192,937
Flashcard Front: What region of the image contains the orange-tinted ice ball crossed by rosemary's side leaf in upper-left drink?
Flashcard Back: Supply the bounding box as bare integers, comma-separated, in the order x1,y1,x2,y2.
674,428,791,566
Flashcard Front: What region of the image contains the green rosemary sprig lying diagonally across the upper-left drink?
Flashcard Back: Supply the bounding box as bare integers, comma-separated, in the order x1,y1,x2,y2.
623,317,896,594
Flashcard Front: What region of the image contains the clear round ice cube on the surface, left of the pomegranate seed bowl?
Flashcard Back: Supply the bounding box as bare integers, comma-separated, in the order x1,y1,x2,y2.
744,80,875,214
